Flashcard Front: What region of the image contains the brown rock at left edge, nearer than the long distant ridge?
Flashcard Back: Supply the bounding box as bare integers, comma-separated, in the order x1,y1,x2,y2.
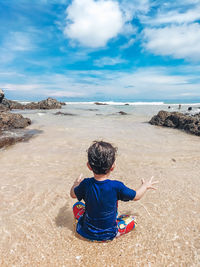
0,112,31,131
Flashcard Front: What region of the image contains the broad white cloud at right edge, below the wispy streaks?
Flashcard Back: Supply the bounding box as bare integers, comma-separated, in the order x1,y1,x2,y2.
143,23,200,61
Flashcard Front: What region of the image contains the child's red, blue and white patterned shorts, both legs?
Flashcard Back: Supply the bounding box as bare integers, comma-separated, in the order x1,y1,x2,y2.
73,202,136,237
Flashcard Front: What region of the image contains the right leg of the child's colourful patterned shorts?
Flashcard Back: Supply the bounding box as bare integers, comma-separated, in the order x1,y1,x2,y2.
117,215,136,237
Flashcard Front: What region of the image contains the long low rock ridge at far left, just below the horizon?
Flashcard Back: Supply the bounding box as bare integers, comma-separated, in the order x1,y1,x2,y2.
0,97,62,110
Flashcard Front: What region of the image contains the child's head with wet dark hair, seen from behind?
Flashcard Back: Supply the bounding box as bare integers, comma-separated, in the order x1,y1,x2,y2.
87,141,117,174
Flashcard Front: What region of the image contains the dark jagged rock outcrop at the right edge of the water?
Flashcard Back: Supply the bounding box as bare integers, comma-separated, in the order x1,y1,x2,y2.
149,110,200,136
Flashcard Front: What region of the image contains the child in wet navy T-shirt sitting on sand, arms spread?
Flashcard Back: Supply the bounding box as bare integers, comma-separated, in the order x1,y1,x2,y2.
70,141,157,241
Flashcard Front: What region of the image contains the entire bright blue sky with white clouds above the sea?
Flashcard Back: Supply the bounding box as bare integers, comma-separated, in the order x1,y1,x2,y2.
0,0,200,101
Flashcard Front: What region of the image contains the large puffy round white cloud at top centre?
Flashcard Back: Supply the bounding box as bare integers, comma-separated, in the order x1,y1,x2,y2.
64,0,124,48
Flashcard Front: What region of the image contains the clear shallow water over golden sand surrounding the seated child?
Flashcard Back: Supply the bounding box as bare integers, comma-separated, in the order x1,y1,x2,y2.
0,105,200,267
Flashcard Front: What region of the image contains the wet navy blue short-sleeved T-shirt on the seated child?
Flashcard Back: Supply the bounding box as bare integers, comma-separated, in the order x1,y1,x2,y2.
74,178,136,240
